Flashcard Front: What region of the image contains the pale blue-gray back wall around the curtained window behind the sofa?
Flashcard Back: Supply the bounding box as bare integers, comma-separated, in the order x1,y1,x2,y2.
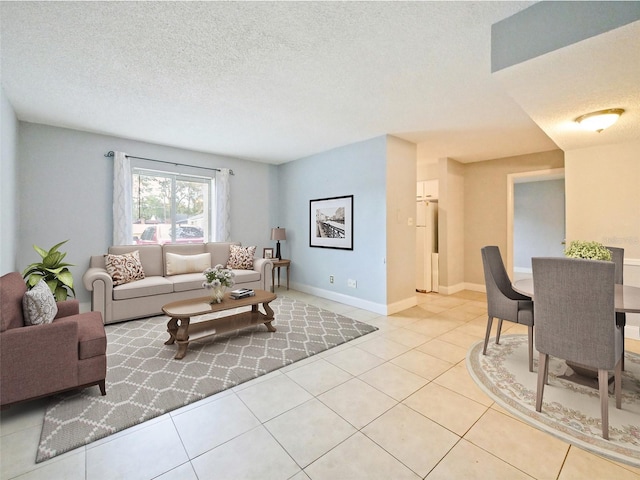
15,122,277,303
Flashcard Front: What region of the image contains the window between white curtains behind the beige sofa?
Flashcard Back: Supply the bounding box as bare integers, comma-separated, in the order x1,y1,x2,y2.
132,167,214,245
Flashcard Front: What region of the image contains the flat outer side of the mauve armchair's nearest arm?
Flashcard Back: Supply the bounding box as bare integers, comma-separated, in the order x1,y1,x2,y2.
0,320,78,405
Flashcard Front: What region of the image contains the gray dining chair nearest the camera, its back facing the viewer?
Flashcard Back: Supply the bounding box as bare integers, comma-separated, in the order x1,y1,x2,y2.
531,257,623,440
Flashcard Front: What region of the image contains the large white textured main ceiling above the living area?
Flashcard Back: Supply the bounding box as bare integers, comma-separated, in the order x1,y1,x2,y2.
0,1,624,164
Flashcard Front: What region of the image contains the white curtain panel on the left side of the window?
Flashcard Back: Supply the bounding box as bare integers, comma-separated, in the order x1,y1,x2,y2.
113,152,133,245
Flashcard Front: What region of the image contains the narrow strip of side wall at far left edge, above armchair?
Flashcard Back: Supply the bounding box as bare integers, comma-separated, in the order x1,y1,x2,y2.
0,87,22,275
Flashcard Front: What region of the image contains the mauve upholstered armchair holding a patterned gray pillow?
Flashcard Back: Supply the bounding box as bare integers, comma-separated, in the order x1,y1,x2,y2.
0,272,107,408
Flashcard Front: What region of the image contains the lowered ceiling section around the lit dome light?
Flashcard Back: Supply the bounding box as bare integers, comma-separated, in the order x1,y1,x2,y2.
495,21,640,151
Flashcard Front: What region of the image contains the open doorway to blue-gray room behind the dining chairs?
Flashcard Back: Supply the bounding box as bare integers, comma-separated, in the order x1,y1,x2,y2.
507,168,565,281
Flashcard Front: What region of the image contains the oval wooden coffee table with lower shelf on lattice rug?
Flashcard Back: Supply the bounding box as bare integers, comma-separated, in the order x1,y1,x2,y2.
162,290,277,360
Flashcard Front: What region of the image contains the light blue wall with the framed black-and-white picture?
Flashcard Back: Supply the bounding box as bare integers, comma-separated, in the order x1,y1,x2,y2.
277,136,388,312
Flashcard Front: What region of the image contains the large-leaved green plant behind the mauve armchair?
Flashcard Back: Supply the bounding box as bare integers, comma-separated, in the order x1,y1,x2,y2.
22,240,76,302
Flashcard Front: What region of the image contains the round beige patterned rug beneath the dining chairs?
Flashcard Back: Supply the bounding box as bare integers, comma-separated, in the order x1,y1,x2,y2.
467,335,640,467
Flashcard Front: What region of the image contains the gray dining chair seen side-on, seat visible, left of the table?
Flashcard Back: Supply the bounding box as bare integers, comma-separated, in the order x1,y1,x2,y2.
480,245,533,372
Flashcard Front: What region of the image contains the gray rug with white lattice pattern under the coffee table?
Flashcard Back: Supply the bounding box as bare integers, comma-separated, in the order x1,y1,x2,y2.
36,297,377,462
